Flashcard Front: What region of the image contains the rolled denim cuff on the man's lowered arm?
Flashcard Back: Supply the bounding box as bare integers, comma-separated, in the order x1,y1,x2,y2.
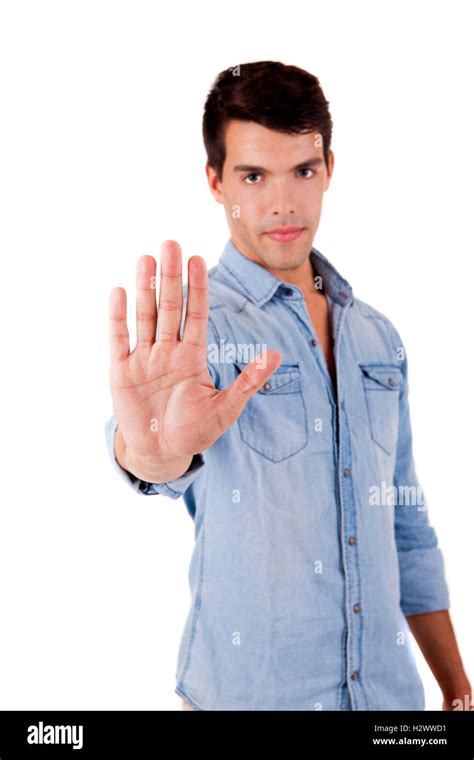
398,547,450,615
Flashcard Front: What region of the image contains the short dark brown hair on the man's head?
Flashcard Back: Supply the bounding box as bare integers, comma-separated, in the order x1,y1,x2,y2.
202,61,332,181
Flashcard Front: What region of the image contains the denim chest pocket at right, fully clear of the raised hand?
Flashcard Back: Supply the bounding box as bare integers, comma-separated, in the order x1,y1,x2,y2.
359,364,403,454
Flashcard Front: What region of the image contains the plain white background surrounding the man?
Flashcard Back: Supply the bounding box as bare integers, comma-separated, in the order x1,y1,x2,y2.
0,0,474,710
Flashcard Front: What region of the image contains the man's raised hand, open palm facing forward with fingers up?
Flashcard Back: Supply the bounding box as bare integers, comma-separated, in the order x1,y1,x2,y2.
109,240,282,482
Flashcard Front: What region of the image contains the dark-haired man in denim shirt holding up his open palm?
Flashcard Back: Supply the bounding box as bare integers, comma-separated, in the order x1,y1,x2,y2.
106,61,471,710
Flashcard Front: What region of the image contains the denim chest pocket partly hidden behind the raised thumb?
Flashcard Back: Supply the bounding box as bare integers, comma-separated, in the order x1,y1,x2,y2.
234,362,308,462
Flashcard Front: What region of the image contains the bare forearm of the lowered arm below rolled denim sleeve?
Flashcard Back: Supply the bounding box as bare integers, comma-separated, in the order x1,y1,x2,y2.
407,610,471,709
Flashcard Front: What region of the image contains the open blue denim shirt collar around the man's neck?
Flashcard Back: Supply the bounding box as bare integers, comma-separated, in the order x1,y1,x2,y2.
218,238,353,306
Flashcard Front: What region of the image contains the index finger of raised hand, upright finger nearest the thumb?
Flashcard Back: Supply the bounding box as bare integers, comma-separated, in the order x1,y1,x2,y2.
183,256,209,352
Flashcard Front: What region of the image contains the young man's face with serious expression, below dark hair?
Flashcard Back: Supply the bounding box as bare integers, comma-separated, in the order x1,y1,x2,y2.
206,120,334,270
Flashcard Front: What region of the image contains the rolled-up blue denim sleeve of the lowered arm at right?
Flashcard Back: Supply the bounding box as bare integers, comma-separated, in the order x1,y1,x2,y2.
394,341,450,615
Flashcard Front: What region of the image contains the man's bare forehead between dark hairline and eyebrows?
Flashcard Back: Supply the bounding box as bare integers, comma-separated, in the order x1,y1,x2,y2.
225,119,323,166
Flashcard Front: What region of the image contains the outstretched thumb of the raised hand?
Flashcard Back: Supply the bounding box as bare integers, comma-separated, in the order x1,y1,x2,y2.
216,350,283,432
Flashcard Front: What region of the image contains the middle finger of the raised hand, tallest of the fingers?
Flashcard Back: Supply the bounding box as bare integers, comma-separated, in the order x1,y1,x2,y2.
158,240,183,343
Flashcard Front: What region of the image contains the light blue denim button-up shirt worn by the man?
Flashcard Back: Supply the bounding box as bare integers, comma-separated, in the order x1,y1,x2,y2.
106,239,449,710
